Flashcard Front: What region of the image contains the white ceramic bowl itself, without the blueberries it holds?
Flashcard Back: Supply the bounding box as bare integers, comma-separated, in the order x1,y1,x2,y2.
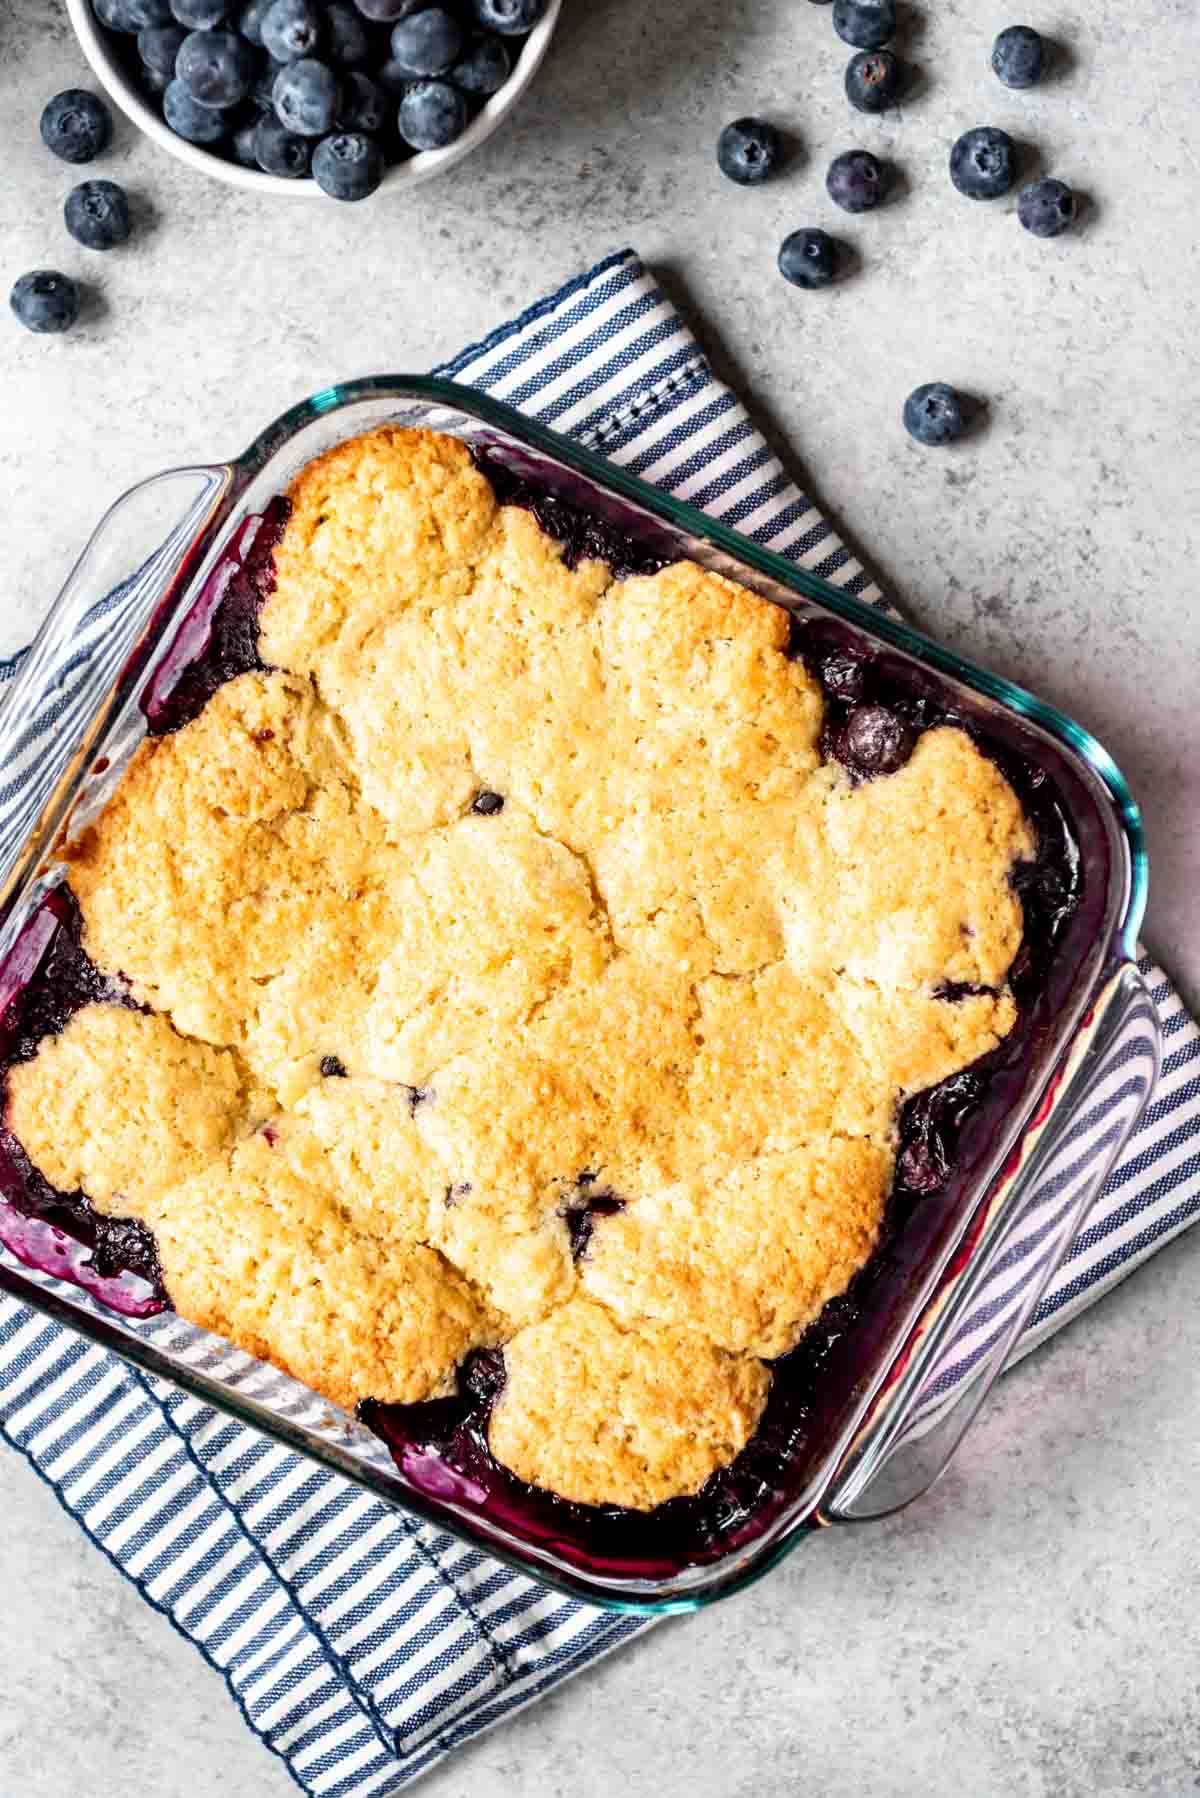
67,0,563,200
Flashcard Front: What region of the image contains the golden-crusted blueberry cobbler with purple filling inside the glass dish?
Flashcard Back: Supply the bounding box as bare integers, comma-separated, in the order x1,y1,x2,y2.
4,430,1069,1539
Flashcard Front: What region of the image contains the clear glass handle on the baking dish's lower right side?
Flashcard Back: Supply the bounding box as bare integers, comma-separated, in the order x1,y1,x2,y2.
820,962,1160,1523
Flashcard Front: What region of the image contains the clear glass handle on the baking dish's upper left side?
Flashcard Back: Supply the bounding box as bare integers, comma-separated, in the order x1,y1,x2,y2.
0,466,234,903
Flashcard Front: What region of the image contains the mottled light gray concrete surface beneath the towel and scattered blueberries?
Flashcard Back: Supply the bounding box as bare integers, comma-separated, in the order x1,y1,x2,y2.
0,0,1200,1798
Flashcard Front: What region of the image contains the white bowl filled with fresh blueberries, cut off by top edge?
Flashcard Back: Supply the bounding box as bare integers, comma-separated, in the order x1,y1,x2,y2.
67,0,561,200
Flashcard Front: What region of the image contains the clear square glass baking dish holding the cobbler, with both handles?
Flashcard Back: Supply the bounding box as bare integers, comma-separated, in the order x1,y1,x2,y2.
0,376,1159,1611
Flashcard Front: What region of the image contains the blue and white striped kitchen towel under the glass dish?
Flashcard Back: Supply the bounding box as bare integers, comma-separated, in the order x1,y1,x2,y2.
0,252,1200,1798
